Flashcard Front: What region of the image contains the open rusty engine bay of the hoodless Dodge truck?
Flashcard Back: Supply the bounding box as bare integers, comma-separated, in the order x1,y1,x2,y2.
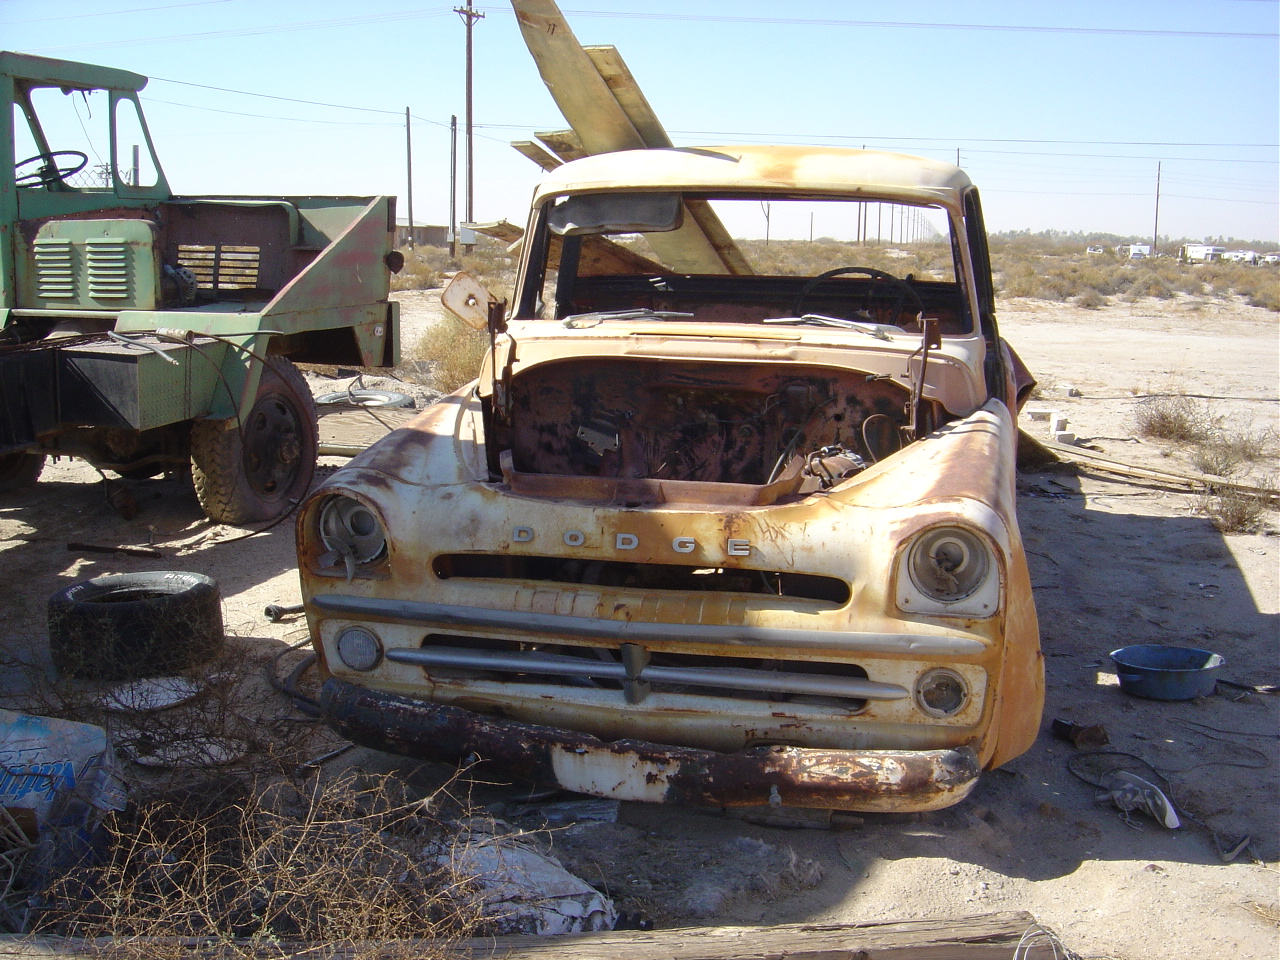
488,357,931,485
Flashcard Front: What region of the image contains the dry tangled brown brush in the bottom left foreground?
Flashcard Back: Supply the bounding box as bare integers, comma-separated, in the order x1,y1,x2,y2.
36,773,477,960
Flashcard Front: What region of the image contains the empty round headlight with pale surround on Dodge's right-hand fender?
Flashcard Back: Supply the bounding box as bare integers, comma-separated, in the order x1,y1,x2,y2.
897,524,1000,617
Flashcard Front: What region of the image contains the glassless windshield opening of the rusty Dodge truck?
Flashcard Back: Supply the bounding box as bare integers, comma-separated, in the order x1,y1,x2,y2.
520,192,973,335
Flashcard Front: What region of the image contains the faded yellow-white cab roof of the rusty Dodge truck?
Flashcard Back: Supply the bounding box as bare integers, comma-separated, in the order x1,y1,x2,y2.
536,145,972,210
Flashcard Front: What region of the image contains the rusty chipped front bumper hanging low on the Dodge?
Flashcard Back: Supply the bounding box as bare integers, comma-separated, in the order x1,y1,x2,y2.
320,678,979,813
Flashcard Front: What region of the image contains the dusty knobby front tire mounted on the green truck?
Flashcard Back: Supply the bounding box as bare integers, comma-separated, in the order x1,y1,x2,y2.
191,357,320,525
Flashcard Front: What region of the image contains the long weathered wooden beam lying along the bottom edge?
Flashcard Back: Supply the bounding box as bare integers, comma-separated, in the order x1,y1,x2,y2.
0,911,1066,960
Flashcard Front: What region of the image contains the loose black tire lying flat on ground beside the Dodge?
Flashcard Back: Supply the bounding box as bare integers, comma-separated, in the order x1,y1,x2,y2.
47,570,223,680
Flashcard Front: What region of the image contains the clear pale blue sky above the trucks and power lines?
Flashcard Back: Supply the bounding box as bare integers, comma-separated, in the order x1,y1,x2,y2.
0,0,1280,242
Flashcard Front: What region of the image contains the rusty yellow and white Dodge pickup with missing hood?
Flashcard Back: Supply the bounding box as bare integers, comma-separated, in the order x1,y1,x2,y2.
297,146,1043,812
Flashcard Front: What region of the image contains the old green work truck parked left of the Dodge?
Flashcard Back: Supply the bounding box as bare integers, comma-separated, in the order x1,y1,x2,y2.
0,52,403,524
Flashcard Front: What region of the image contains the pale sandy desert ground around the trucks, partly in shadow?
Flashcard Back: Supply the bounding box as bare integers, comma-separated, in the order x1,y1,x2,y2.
0,294,1280,960
